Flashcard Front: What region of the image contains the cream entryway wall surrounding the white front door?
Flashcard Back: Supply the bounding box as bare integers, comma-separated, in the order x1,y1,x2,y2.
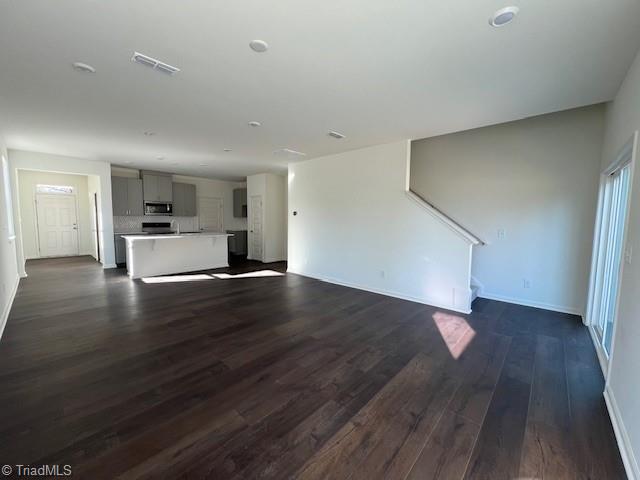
18,170,94,259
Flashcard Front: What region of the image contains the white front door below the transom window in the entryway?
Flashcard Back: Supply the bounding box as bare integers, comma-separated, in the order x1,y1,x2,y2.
36,194,79,257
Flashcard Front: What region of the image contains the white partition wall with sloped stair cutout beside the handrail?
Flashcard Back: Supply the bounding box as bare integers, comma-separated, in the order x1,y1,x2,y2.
288,141,470,311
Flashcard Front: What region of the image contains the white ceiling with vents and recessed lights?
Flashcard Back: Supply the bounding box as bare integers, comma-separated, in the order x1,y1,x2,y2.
0,0,640,179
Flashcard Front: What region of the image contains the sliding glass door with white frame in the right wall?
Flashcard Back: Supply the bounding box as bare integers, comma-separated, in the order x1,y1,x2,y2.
586,134,637,374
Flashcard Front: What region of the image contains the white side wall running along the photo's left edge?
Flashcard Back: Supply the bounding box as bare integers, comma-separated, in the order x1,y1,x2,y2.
0,136,19,337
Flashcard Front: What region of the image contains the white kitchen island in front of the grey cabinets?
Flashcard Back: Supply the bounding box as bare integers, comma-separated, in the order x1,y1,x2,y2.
123,232,231,278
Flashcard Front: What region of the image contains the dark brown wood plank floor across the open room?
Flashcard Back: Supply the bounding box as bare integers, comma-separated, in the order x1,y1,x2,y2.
0,258,625,480
